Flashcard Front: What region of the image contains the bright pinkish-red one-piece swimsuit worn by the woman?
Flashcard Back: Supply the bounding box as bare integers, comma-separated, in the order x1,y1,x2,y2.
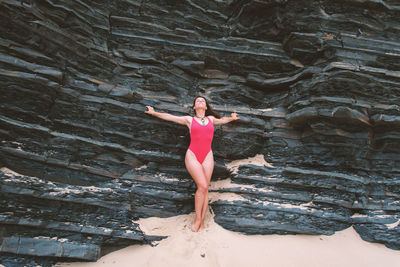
189,117,214,164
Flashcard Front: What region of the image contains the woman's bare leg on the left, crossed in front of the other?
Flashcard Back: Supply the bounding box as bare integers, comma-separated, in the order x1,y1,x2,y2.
185,150,208,232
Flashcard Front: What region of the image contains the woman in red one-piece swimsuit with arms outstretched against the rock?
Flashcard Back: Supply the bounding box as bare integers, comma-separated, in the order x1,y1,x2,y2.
145,96,239,232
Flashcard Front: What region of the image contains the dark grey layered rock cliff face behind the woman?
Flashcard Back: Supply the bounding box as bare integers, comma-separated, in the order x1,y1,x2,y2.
0,0,400,266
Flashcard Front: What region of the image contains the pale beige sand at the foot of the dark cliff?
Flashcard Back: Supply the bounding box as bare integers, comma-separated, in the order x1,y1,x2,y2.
56,209,400,267
